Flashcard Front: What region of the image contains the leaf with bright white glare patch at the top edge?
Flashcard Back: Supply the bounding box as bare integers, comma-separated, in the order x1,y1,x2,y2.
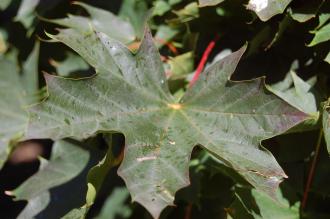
247,0,292,21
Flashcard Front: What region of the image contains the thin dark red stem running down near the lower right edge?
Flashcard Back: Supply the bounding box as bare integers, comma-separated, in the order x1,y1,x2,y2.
301,129,323,210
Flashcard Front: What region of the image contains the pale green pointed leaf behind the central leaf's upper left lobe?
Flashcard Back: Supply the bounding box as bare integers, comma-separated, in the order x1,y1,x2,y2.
46,2,136,43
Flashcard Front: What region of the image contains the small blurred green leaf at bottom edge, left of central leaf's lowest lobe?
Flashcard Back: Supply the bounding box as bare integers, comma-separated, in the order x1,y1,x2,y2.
96,188,132,219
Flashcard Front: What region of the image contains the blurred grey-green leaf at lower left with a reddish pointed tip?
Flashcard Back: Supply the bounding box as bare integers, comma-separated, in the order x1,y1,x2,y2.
10,141,90,218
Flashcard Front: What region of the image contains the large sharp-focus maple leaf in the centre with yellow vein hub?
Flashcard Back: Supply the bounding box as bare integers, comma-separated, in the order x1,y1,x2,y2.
28,29,307,218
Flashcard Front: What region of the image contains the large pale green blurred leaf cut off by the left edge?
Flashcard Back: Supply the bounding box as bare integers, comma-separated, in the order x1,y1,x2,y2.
0,43,39,168
